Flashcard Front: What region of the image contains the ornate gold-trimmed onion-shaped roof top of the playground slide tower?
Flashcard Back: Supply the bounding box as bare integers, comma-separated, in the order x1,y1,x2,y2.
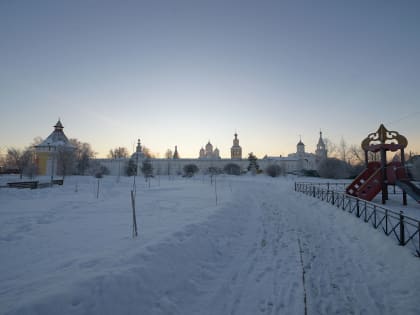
362,124,408,151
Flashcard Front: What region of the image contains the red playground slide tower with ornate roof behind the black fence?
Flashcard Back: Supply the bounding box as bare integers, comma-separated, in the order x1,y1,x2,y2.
346,124,420,205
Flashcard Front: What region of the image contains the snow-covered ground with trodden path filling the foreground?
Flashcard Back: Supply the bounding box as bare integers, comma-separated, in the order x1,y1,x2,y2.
0,175,420,315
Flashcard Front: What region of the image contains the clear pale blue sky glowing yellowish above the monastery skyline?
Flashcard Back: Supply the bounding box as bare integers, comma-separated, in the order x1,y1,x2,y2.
0,0,420,157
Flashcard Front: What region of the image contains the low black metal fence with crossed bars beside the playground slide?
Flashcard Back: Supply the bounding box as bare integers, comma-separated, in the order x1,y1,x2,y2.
295,182,420,257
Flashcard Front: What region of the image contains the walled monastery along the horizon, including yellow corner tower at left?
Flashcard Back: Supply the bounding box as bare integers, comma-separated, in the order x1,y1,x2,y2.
35,120,328,175
